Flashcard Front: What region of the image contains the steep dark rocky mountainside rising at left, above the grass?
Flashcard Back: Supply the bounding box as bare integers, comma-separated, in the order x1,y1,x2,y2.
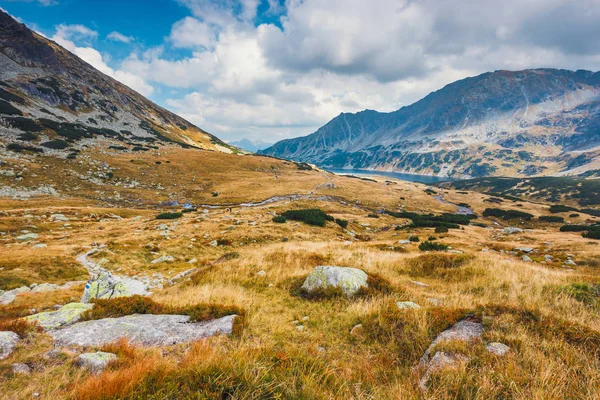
0,10,235,158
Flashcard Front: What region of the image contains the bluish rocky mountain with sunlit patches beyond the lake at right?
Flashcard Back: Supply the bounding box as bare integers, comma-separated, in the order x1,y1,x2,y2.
263,69,600,177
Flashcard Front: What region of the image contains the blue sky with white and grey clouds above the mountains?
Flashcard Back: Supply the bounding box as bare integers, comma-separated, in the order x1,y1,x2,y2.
0,0,600,142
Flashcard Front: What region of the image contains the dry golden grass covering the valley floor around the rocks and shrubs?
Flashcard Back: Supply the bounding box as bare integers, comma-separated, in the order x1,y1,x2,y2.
0,149,600,399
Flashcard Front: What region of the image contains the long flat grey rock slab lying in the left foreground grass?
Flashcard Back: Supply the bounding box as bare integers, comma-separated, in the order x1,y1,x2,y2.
50,314,236,347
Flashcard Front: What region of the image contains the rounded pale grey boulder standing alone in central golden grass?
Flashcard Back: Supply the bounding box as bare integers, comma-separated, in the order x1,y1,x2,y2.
302,266,368,296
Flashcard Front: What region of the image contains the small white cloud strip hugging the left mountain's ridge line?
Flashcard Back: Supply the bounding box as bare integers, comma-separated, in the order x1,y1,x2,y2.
51,25,154,96
